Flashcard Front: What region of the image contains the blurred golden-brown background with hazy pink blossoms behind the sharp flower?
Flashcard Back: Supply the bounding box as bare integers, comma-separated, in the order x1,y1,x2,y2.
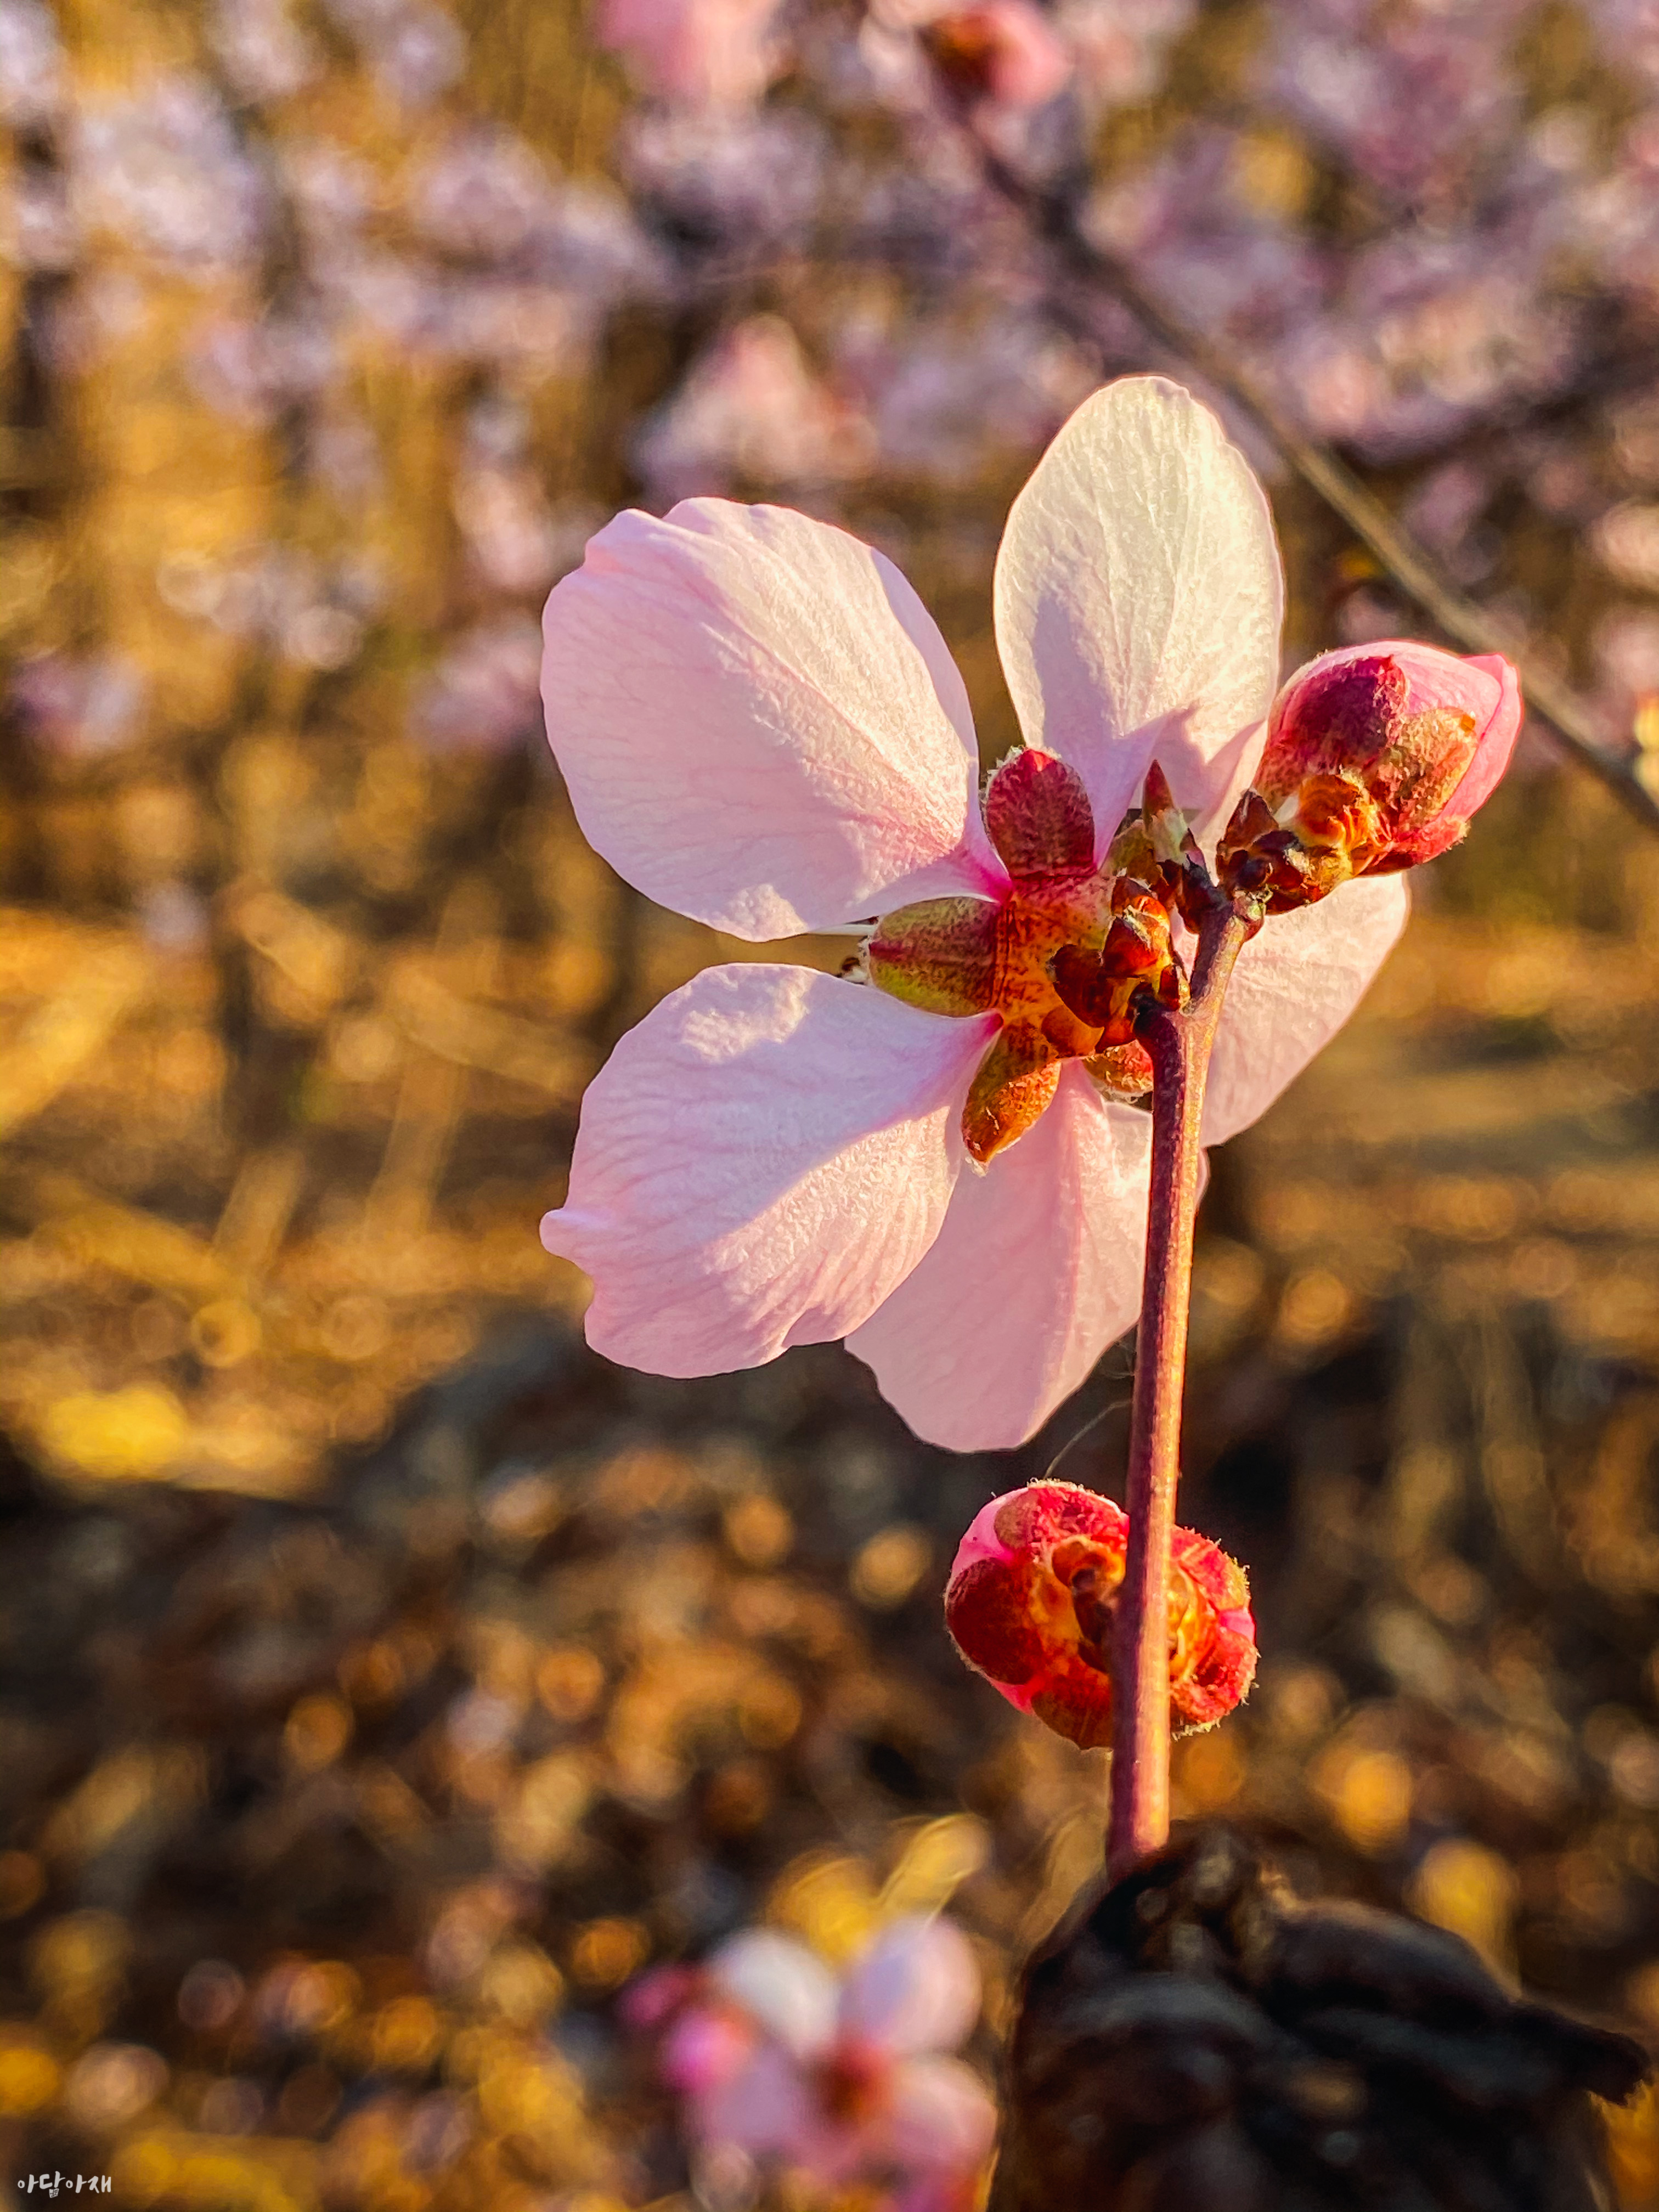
0,0,1659,2212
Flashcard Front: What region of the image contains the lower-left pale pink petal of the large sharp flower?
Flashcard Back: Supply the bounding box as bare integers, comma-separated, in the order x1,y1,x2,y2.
542,964,995,1376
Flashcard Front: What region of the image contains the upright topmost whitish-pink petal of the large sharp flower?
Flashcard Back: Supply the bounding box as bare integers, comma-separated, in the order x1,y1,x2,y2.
995,376,1285,851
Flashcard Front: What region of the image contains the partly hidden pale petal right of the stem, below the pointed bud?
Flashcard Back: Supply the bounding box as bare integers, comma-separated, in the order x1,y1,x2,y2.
1203,876,1411,1144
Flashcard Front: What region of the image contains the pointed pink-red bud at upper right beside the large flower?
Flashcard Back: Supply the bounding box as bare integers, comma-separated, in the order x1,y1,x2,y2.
1219,641,1522,909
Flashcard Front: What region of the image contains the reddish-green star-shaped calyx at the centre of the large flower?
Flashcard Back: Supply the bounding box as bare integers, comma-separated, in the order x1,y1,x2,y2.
867,746,1175,1166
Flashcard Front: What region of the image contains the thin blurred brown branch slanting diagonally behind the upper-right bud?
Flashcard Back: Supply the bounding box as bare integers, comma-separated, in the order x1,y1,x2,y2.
975,135,1659,830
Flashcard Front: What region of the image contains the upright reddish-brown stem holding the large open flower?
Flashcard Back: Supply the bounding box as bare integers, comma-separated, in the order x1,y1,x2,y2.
1106,902,1259,1882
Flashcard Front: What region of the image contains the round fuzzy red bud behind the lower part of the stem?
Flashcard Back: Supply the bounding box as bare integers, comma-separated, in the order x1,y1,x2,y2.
945,1482,1256,1750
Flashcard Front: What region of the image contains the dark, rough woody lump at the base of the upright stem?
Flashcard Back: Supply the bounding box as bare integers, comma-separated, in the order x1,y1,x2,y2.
991,1825,1648,2212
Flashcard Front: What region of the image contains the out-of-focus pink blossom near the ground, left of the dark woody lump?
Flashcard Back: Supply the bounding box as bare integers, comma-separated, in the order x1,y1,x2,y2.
624,1916,995,2205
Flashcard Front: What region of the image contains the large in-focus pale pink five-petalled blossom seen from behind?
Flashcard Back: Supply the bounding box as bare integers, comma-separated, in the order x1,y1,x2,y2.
542,376,1407,1451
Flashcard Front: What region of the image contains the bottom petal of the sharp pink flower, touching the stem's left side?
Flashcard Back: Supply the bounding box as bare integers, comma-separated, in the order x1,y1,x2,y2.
847,1062,1153,1451
